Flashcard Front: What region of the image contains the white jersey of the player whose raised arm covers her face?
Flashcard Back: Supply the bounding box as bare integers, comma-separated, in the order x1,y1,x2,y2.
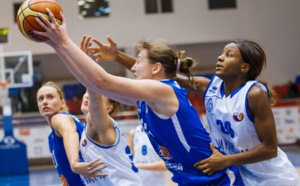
80,119,143,186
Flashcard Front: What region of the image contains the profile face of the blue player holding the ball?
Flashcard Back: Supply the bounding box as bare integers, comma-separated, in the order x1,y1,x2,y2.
131,50,154,79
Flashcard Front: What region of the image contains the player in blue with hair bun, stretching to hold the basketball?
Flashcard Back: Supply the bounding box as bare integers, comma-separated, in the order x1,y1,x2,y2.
35,10,243,185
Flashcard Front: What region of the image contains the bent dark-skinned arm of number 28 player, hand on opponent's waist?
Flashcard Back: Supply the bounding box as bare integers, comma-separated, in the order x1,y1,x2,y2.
195,86,277,175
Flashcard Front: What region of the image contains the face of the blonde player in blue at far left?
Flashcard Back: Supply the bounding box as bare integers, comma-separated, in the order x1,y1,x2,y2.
37,86,65,117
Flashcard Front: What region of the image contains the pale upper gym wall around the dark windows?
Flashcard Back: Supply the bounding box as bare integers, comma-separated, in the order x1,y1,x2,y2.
0,0,300,85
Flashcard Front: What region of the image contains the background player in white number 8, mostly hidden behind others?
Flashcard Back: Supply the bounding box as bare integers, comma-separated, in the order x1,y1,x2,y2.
128,125,168,186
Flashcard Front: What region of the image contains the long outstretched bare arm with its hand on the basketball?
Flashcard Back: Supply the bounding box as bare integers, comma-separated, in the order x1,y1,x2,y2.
35,9,176,115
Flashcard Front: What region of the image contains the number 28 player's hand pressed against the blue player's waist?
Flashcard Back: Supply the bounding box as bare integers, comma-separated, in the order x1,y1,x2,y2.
194,142,226,176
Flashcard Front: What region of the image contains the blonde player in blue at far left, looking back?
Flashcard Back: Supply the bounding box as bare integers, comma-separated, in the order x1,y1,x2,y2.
37,82,104,186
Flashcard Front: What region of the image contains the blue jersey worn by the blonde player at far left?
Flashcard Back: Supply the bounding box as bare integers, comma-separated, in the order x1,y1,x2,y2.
48,112,84,186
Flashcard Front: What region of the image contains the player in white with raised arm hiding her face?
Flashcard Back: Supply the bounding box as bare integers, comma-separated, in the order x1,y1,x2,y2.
74,41,143,186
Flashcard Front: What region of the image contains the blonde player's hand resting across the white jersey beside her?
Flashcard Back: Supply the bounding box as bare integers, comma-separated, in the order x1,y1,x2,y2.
71,159,108,183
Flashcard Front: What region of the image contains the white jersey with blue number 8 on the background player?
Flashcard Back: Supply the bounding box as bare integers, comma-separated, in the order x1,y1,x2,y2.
133,126,167,186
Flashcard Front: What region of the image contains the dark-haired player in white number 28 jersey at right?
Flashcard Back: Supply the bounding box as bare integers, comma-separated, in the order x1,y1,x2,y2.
91,37,299,185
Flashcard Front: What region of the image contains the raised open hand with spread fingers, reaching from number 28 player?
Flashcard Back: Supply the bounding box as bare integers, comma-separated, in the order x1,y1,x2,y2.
89,36,118,62
